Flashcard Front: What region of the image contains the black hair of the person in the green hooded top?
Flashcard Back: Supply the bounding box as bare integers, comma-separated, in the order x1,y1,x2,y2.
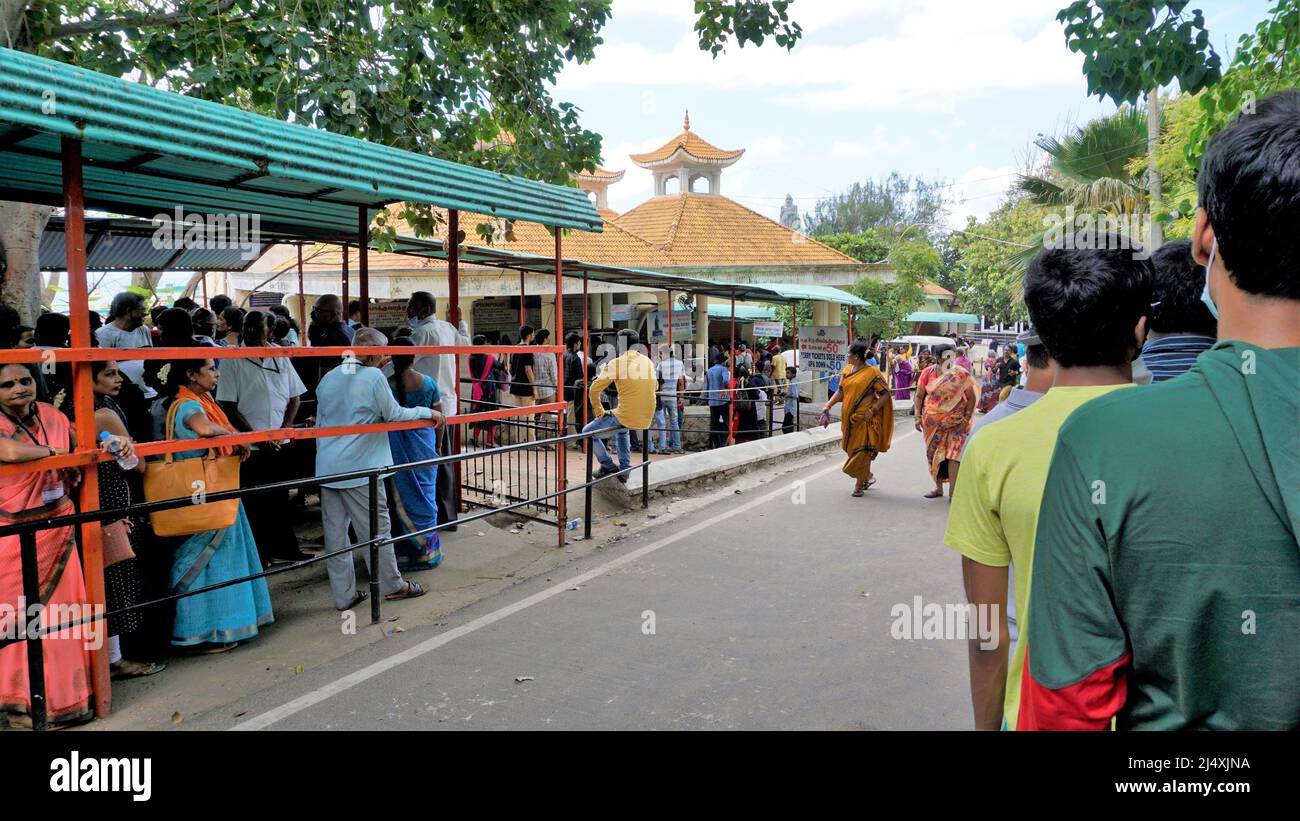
1197,88,1300,299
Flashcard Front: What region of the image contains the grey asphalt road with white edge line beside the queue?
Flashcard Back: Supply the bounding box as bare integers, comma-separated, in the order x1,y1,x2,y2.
186,420,970,730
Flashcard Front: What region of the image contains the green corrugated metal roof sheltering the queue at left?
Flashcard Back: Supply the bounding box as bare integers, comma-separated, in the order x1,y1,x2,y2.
0,48,603,239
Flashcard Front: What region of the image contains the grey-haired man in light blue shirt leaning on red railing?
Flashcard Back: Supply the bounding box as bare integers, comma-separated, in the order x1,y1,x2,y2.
316,329,442,611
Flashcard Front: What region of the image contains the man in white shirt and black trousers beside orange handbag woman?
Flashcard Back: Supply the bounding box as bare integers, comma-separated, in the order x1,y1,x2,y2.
217,310,309,565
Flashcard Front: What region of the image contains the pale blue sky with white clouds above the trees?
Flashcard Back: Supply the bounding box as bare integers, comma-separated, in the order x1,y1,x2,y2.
555,0,1273,226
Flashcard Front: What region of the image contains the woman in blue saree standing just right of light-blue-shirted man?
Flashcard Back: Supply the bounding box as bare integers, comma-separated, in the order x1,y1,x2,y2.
387,338,446,573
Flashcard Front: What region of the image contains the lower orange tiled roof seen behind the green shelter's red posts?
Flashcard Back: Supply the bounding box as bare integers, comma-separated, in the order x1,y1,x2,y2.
276,212,673,277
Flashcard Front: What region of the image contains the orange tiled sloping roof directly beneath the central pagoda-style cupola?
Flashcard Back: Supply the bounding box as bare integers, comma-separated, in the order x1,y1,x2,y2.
611,194,859,265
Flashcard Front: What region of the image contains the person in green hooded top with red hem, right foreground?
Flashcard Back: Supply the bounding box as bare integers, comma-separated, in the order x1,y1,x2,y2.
1013,91,1300,730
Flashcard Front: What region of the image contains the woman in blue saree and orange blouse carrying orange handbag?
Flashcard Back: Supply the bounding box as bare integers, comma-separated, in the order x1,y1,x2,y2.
166,360,276,652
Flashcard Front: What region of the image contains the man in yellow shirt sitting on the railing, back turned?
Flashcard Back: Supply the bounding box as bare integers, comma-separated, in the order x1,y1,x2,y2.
582,330,659,485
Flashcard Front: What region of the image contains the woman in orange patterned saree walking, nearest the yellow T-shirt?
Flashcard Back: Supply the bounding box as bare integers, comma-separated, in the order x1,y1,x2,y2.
917,351,978,499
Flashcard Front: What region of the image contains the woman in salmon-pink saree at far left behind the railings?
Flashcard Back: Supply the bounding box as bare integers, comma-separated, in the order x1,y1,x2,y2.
0,365,103,726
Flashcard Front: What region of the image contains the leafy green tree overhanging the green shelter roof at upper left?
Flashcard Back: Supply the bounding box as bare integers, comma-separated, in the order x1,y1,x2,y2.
0,0,801,321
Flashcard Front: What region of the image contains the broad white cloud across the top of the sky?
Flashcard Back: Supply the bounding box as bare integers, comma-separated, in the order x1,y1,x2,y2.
559,0,1083,112
